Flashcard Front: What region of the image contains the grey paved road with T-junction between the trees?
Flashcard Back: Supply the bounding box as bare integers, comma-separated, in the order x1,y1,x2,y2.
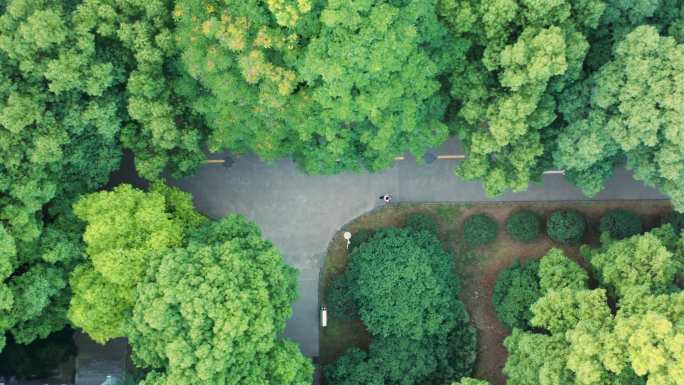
172,138,665,357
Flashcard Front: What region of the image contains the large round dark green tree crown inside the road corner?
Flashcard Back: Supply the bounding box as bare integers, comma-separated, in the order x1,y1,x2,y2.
347,228,462,339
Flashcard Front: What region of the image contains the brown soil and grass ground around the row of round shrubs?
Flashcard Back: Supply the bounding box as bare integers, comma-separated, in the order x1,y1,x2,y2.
319,200,672,385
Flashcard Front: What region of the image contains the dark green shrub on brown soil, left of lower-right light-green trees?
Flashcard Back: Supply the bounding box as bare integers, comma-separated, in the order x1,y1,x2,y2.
492,261,541,330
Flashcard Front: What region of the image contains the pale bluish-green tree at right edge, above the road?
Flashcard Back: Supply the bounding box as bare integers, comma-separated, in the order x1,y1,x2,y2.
555,25,684,209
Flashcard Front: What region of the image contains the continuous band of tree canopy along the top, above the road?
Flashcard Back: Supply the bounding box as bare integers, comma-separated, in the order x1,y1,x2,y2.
0,0,684,212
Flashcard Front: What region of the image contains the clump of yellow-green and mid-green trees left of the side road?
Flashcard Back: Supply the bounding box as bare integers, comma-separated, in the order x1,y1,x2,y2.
69,184,313,385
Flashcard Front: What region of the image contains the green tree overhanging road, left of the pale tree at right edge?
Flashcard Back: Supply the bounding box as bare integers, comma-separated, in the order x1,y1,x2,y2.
440,0,605,195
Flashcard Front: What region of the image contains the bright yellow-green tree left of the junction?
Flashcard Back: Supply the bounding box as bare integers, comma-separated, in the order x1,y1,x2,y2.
69,185,190,342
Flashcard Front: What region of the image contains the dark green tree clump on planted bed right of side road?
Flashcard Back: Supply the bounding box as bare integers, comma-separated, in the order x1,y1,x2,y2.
325,224,476,385
